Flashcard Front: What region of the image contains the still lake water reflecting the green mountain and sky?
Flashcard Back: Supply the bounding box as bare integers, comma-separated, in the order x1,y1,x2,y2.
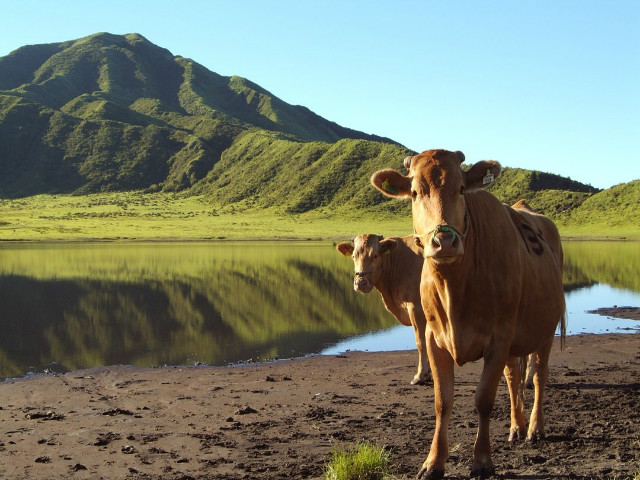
0,242,640,379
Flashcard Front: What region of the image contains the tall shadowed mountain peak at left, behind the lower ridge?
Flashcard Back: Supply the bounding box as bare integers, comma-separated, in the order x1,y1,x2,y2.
0,33,393,197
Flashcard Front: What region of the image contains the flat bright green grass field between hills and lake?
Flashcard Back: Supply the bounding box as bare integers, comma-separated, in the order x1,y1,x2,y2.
0,192,640,241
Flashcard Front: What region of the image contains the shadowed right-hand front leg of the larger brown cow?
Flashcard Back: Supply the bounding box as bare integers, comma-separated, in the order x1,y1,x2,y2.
471,344,509,478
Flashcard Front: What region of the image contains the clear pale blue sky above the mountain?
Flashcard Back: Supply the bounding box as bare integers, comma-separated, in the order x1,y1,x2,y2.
0,0,640,188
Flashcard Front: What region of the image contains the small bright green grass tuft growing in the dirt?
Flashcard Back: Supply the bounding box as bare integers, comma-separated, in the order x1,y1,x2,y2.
325,442,390,480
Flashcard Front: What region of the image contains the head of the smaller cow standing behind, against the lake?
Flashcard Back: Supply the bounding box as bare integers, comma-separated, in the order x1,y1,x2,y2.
336,234,397,293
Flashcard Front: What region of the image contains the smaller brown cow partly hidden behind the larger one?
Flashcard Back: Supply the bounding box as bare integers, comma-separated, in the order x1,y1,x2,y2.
336,234,431,385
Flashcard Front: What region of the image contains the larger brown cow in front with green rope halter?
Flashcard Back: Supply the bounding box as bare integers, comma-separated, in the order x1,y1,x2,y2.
371,150,565,478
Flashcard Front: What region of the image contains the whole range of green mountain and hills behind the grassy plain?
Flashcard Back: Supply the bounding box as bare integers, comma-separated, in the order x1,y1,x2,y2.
0,33,639,229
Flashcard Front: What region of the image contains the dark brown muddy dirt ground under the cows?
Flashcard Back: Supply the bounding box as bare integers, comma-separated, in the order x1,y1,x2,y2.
0,333,640,480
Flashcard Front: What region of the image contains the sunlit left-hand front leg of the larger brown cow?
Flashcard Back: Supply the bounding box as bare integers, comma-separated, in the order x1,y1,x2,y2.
418,331,454,480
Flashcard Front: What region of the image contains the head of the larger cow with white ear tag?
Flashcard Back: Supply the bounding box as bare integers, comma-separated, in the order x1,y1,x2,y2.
371,150,501,263
